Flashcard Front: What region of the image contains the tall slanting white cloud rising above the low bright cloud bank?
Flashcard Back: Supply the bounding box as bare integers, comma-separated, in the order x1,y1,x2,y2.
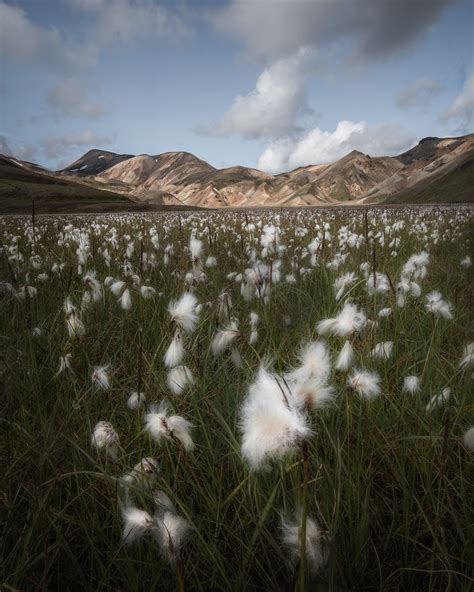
197,48,316,139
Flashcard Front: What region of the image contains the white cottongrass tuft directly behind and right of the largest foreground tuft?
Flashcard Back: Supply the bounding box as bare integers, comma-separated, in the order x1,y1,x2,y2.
285,341,334,409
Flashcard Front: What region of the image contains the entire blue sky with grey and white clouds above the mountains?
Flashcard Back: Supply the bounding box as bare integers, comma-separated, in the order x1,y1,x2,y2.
0,0,474,173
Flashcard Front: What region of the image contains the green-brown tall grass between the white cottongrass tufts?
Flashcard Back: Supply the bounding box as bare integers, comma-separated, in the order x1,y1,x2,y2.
0,209,474,591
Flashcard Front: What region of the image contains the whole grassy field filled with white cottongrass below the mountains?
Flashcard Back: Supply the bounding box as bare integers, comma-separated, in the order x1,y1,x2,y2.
0,207,474,592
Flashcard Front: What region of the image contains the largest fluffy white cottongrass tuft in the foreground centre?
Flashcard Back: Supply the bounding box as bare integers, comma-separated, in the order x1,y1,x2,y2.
240,367,312,470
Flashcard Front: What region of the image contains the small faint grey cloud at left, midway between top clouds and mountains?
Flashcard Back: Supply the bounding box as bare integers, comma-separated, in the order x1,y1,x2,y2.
46,78,105,119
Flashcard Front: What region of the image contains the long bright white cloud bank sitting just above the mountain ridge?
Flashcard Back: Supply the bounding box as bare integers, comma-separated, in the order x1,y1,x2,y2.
258,121,415,173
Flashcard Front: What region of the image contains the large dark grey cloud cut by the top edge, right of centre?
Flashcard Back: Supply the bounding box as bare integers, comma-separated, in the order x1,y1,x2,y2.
211,0,450,62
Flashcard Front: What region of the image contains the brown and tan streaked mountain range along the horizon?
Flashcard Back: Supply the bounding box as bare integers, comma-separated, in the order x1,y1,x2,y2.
0,134,474,213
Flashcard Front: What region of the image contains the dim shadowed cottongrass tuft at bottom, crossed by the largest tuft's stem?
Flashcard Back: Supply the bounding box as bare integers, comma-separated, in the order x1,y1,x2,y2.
281,511,328,574
